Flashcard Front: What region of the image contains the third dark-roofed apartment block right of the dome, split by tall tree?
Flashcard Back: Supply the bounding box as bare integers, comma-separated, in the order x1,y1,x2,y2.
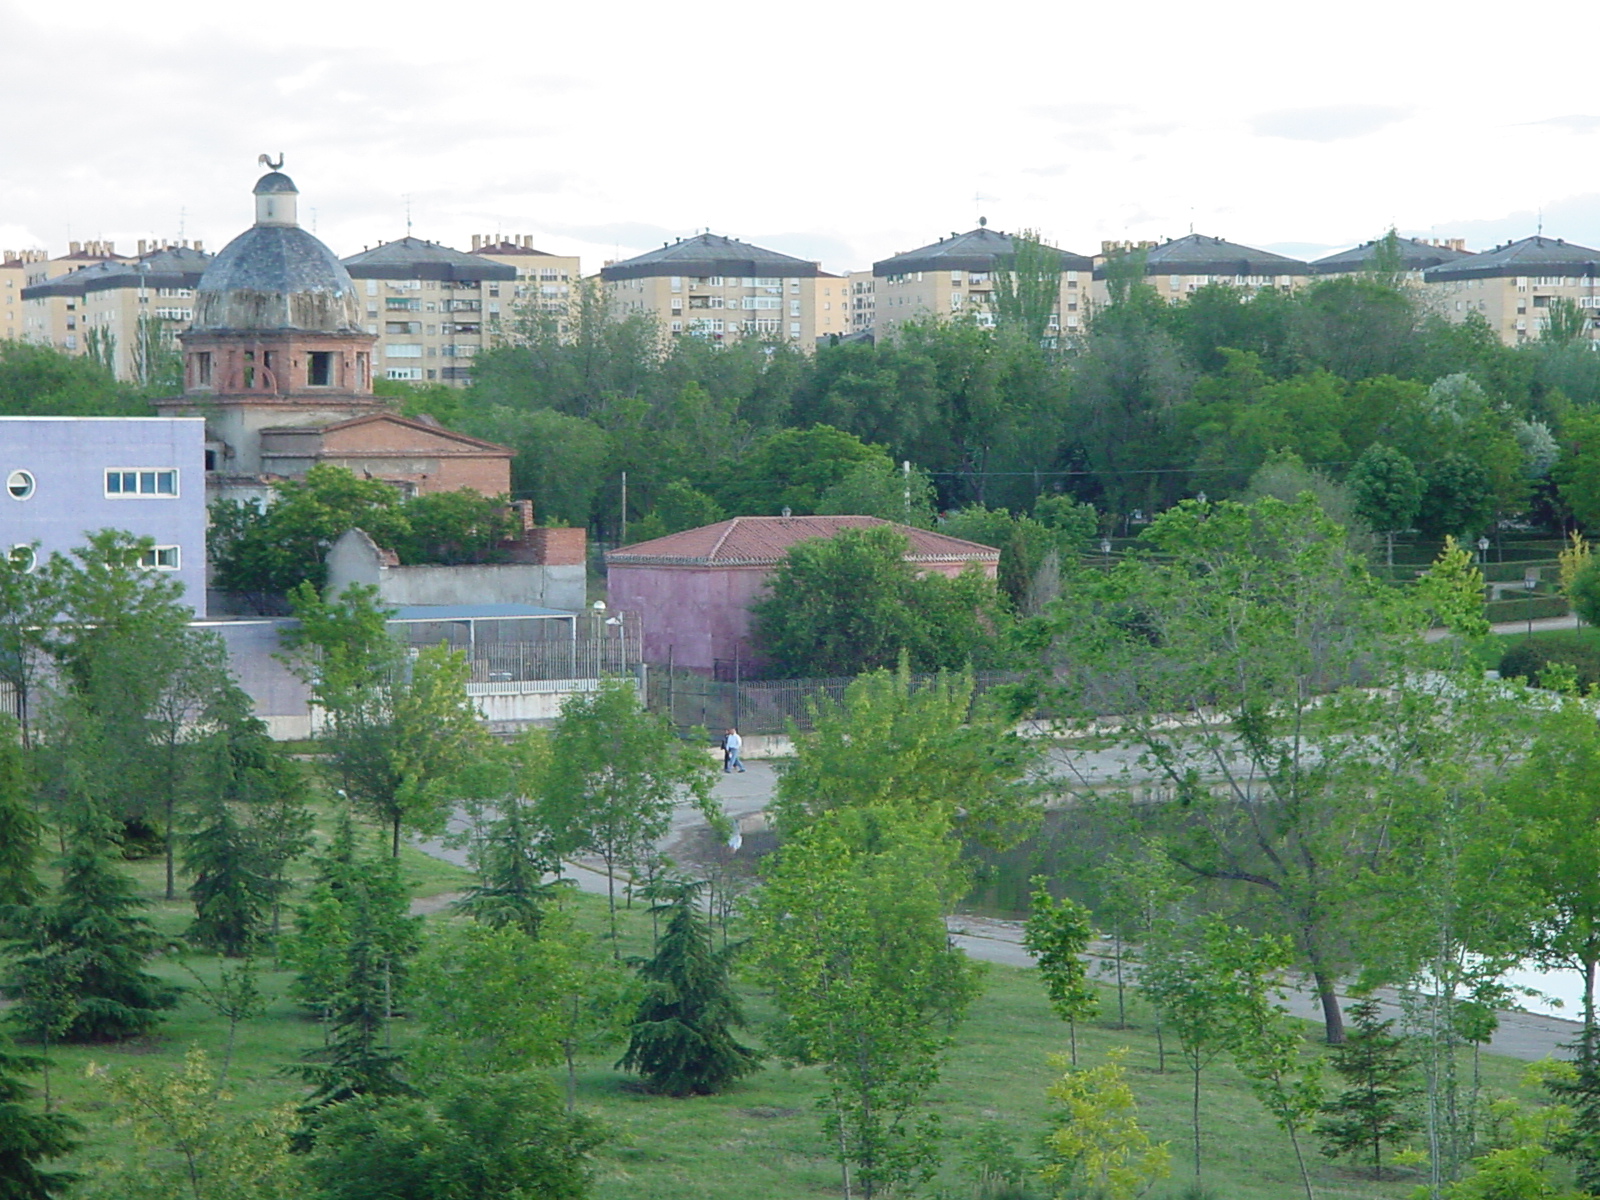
872,222,1094,338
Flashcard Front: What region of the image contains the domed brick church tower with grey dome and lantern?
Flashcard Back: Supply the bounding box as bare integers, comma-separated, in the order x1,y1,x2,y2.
157,157,389,486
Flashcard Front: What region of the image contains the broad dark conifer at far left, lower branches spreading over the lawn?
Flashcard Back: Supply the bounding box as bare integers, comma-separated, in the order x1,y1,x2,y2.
0,830,179,1042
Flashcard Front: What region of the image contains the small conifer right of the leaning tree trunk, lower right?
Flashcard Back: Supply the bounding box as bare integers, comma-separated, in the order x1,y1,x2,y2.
1317,1000,1421,1179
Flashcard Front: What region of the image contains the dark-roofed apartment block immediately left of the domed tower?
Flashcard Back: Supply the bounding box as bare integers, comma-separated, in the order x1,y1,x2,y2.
22,249,211,382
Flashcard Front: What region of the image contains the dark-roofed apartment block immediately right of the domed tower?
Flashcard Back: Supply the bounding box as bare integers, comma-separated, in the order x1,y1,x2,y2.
342,235,517,387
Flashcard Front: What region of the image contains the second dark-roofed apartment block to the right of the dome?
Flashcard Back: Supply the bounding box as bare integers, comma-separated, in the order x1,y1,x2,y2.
600,234,837,346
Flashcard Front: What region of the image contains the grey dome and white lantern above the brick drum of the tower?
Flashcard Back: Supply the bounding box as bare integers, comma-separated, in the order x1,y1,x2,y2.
190,162,362,333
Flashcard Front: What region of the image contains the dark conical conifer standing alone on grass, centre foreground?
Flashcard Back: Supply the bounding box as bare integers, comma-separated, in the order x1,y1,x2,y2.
618,883,760,1096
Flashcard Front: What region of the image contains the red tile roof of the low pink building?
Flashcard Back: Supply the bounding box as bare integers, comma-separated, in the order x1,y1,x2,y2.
605,517,1000,566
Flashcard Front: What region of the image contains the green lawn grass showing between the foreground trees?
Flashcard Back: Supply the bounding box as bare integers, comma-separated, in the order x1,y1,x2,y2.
28,859,1561,1200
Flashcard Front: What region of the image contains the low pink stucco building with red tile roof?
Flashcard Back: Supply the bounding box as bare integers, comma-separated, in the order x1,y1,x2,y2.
605,517,1000,674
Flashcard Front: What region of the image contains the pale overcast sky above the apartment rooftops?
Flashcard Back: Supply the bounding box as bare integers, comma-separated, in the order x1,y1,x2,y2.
0,0,1600,272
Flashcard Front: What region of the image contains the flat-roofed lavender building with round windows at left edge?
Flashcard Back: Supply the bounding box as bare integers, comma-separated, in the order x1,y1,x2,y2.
0,416,206,616
